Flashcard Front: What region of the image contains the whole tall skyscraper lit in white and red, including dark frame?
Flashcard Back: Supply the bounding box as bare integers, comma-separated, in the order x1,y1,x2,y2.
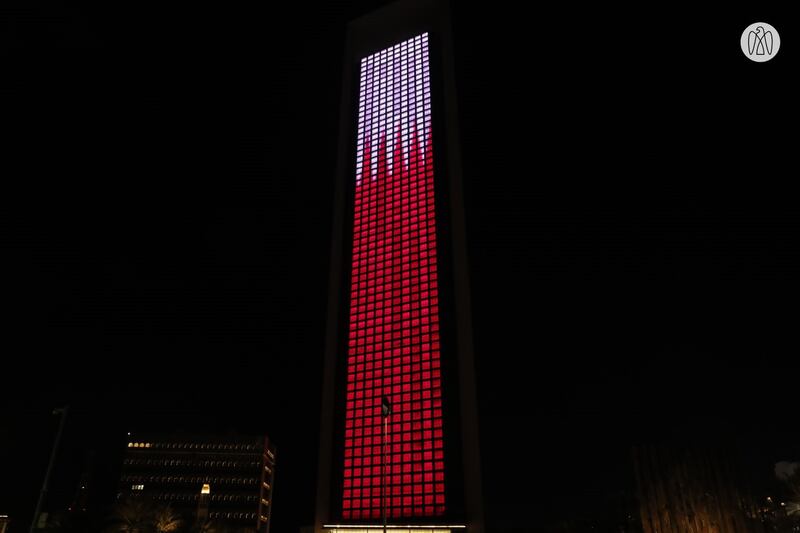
316,1,483,531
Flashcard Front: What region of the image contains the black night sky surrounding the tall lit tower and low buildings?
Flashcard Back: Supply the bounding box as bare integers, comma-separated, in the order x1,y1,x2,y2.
0,1,800,533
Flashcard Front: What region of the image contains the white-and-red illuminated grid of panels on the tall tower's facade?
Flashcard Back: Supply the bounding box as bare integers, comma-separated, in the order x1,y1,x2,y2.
342,34,445,520
